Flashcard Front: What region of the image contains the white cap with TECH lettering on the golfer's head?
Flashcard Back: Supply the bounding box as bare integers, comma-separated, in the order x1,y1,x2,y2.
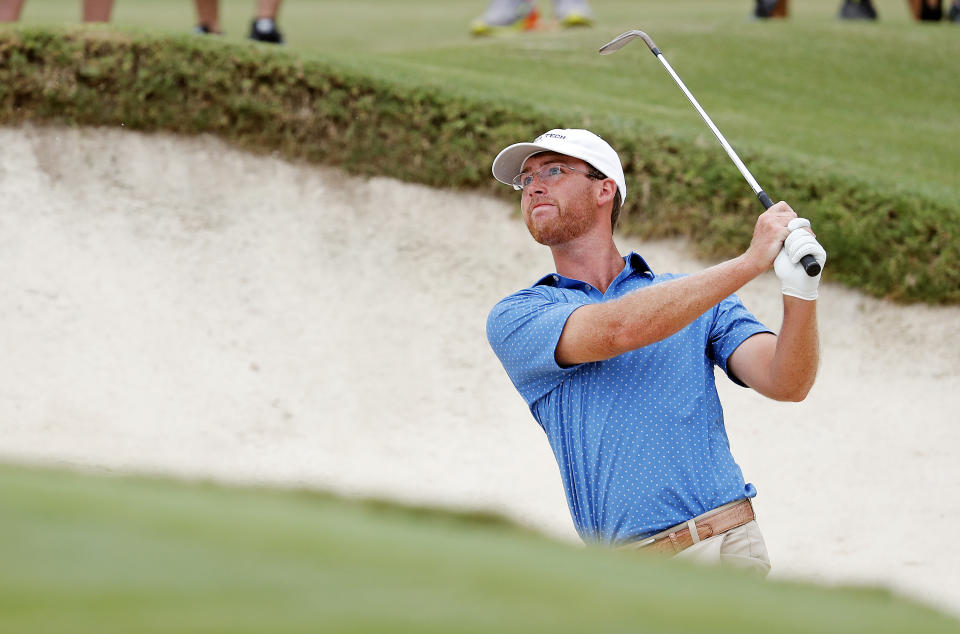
493,129,627,202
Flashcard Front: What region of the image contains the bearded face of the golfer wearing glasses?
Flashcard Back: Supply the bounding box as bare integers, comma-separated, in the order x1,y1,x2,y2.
520,152,597,246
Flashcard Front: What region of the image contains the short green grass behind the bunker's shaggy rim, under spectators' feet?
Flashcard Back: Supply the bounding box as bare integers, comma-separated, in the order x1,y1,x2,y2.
9,0,960,204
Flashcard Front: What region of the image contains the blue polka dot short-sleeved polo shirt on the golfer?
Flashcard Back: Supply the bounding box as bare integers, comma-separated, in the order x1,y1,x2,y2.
487,253,770,544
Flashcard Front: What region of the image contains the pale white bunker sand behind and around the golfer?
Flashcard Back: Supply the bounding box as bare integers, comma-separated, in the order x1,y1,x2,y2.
0,127,960,614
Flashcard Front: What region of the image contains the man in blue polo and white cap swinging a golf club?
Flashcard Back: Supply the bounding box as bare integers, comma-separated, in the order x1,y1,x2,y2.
487,130,826,574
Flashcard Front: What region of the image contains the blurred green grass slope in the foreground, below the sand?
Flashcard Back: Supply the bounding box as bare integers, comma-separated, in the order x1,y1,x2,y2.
0,465,960,633
